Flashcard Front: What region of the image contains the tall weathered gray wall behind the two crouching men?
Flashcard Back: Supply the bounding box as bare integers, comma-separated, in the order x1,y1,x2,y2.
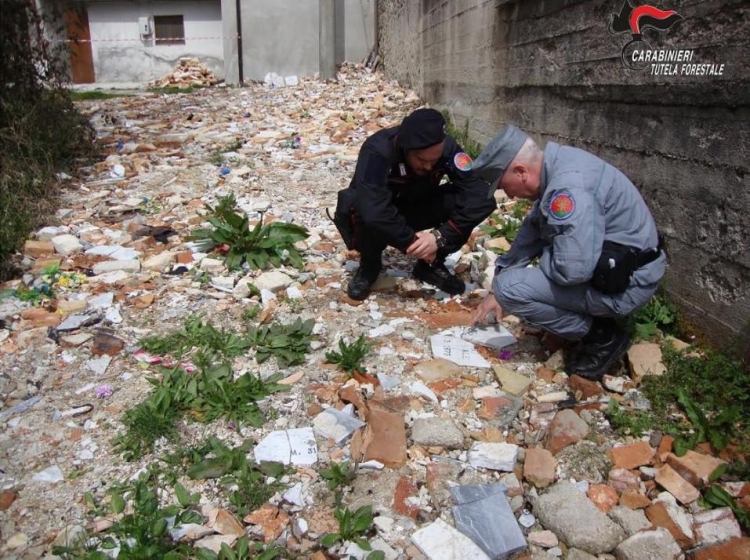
379,0,750,349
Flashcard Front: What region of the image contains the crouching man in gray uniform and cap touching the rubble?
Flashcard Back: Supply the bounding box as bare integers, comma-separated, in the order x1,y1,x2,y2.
473,126,666,381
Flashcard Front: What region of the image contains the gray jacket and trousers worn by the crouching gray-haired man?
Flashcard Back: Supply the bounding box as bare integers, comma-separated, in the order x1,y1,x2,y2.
492,142,666,340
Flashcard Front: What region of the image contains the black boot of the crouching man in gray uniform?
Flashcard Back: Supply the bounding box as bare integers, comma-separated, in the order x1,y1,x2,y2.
567,317,630,381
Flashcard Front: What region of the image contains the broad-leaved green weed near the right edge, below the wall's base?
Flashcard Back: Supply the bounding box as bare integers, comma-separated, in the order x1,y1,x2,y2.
674,387,740,456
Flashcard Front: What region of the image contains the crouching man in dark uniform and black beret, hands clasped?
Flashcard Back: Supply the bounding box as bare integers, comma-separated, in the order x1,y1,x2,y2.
334,109,496,300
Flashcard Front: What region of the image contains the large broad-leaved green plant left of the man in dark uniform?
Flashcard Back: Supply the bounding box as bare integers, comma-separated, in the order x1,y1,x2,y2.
190,195,309,270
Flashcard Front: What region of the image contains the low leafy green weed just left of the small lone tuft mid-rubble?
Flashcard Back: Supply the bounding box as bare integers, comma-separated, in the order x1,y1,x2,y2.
247,317,315,367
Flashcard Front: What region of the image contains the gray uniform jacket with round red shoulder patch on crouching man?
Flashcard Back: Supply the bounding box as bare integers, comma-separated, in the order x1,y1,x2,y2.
496,142,666,287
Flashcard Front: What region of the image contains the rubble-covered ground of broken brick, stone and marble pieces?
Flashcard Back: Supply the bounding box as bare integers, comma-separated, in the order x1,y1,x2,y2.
0,66,750,560
